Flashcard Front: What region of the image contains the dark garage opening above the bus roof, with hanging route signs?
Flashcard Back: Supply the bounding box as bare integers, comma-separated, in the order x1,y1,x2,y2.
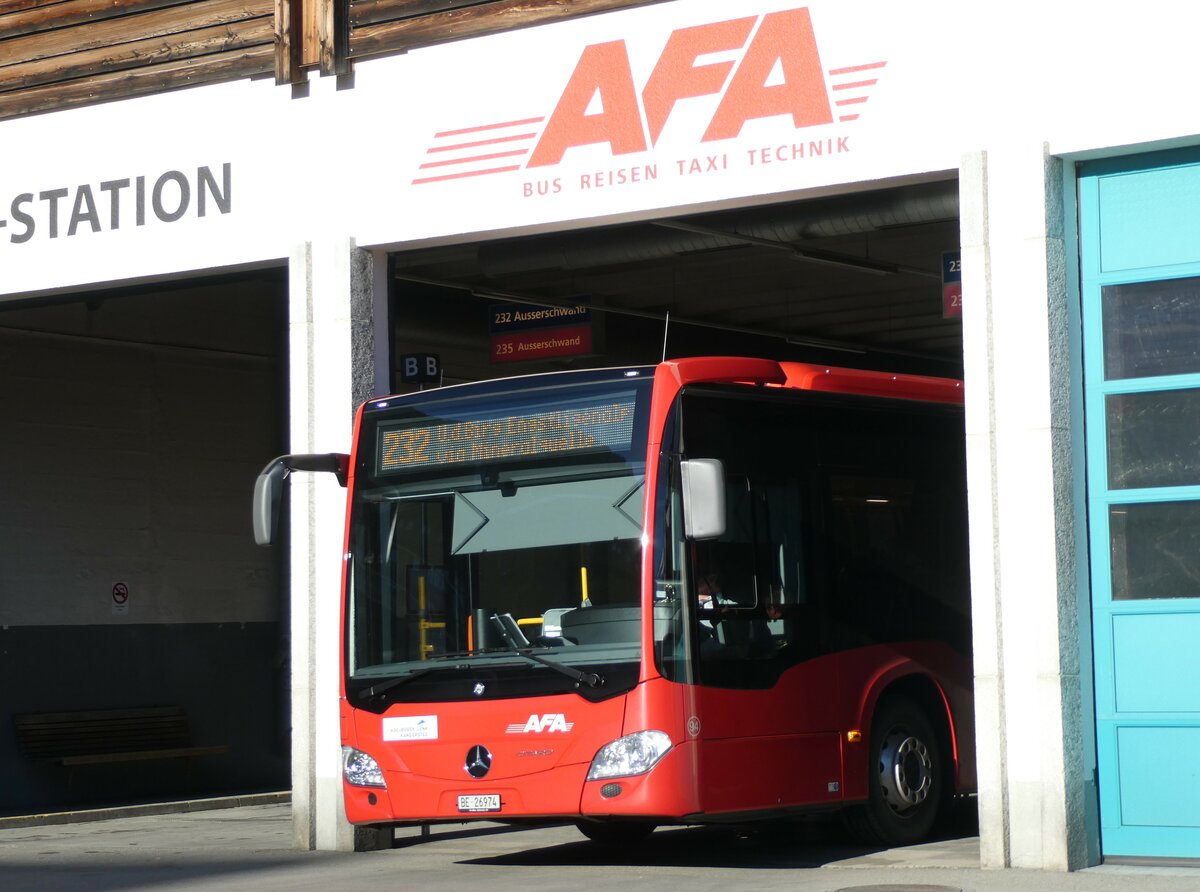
376,172,977,837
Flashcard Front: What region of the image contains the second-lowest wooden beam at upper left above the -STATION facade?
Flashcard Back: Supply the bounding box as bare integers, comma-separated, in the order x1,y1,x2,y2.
0,16,275,92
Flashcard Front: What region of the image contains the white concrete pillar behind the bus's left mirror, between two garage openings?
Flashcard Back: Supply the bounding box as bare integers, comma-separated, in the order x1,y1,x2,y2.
288,239,388,851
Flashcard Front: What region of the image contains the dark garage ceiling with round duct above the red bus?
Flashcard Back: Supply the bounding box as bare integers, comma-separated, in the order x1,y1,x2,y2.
394,180,962,376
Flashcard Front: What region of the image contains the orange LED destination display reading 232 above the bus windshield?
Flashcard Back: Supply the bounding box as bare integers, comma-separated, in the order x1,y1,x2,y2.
377,394,635,474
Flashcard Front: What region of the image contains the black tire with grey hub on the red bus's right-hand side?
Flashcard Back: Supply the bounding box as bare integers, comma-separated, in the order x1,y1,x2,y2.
846,696,946,846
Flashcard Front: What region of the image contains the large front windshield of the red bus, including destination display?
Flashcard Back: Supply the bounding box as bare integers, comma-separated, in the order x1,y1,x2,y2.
346,370,653,710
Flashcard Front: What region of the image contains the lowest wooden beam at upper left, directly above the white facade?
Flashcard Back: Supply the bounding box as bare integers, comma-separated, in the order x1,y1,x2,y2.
0,44,275,119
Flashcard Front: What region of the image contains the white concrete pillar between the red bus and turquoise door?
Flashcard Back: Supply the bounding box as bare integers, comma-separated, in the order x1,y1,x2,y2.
960,144,1096,870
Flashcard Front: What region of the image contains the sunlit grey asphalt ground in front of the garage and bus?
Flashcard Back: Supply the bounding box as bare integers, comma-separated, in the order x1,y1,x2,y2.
0,796,1200,892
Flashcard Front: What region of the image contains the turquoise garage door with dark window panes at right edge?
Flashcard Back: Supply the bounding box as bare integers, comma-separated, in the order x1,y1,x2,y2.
1080,151,1200,857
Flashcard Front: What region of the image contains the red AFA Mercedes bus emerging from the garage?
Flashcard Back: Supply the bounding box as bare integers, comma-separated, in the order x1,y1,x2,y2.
254,358,974,845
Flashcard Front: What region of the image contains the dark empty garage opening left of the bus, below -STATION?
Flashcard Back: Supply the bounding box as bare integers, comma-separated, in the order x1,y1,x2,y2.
0,270,290,814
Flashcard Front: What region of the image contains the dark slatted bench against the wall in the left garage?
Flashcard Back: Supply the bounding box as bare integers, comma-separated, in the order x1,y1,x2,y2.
13,706,229,767
